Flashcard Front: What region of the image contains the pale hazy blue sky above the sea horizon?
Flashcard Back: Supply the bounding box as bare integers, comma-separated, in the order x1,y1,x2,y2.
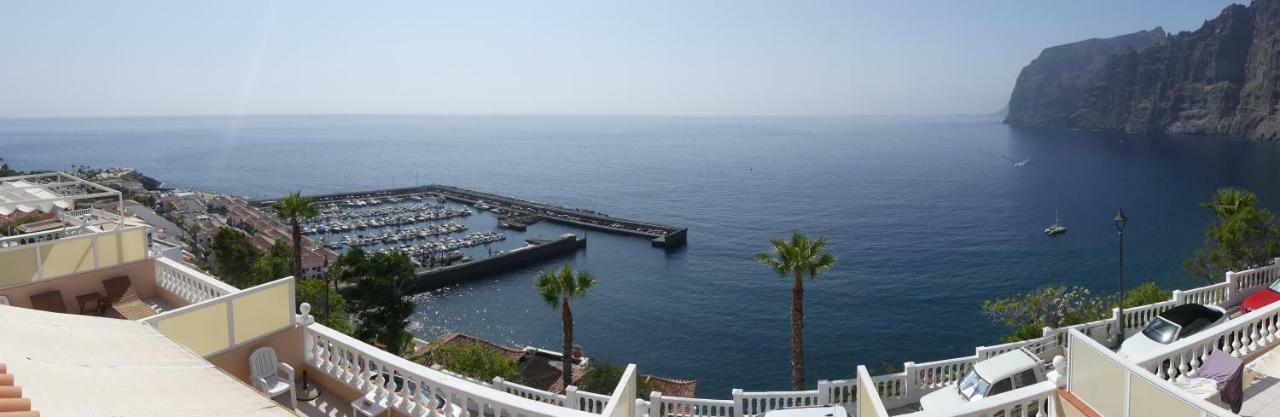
0,0,1229,118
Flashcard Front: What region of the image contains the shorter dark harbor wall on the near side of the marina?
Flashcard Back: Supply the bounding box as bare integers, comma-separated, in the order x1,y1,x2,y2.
413,234,586,293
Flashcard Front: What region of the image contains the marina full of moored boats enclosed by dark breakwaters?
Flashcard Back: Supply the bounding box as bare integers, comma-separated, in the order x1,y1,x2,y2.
251,185,685,292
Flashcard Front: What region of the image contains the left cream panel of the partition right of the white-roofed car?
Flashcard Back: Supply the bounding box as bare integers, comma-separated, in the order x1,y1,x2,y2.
1069,340,1128,416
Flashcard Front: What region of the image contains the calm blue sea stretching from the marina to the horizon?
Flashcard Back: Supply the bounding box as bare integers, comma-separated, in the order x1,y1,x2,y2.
0,116,1280,398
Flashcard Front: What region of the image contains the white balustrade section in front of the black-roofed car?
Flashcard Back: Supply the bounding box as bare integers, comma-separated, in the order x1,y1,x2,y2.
1130,296,1280,380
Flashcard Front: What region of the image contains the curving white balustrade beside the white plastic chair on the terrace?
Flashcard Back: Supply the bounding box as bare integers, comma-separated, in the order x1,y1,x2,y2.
305,324,596,417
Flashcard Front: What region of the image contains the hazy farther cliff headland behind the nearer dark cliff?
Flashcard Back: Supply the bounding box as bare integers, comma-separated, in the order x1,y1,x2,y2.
1005,27,1165,127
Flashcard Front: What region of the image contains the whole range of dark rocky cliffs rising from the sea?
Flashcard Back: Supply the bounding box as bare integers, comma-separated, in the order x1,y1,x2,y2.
1006,0,1280,139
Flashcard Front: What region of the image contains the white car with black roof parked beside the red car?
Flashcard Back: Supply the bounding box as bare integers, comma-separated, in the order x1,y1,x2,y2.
1120,304,1230,358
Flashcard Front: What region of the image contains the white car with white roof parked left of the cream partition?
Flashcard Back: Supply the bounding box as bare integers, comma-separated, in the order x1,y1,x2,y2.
920,349,1044,411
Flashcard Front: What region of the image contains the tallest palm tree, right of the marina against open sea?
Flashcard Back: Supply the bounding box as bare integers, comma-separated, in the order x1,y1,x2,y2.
755,232,836,390
